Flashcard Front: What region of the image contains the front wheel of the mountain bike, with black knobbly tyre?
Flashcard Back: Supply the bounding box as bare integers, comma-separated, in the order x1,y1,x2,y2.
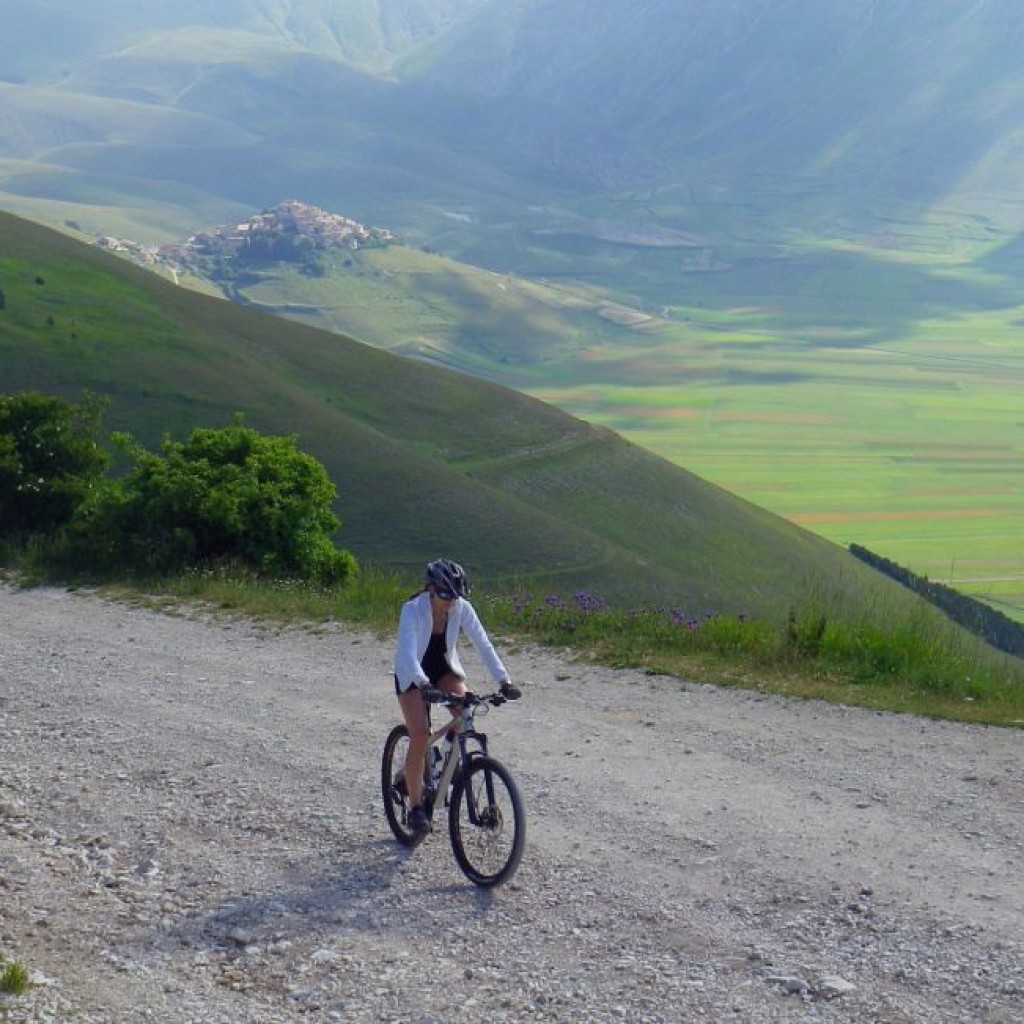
449,757,526,888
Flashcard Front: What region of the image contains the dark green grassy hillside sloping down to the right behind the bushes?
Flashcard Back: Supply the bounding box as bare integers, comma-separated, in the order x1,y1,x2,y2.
0,207,925,615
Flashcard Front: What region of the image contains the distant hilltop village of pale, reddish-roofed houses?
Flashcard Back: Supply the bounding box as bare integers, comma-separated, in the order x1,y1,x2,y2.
96,200,395,273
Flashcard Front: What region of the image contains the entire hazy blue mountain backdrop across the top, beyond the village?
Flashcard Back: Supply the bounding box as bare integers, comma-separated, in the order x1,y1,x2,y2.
6,0,1024,260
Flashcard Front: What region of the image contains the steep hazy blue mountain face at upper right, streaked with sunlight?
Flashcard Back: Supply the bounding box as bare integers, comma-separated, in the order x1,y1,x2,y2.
399,0,1024,234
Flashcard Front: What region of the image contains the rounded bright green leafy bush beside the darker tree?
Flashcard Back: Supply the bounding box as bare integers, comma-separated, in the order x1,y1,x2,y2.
63,423,356,584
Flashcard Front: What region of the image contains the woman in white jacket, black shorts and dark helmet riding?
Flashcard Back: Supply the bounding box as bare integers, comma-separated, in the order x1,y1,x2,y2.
394,558,519,838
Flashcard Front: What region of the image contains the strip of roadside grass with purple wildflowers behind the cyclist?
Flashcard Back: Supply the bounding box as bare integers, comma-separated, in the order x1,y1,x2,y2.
104,567,1024,728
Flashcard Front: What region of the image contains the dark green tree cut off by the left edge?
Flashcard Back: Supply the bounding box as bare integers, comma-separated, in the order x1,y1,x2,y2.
0,391,110,537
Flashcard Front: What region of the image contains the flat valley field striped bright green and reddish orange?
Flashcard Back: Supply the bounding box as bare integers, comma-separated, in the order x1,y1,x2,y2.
534,303,1024,617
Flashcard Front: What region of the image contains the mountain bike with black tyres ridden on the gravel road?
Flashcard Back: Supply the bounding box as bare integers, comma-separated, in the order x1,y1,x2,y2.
381,687,526,888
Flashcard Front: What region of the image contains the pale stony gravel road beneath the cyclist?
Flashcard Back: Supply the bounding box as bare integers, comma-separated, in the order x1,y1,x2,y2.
0,587,1024,1024
